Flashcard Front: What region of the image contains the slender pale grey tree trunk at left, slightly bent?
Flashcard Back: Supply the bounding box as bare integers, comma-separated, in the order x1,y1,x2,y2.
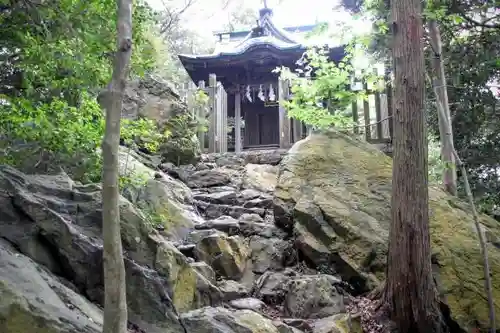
101,0,132,333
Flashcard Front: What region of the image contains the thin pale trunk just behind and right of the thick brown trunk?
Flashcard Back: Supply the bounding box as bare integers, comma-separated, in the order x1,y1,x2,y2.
428,20,457,195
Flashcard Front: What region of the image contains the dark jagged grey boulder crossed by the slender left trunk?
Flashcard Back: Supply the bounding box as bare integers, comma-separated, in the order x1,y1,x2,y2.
0,166,211,333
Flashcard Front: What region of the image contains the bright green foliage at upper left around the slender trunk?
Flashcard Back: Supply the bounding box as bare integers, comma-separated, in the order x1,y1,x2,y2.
0,0,166,182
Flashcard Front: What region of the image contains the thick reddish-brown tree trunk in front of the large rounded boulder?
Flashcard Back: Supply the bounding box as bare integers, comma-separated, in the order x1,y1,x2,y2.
384,0,442,333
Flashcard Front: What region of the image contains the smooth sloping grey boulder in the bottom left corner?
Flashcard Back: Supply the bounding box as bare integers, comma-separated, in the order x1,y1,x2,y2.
0,239,102,333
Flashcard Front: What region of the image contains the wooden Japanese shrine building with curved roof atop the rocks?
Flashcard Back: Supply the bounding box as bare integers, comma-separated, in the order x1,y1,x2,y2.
179,7,344,152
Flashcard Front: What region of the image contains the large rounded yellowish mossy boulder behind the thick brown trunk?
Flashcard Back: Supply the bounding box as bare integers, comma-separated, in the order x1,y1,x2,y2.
274,132,500,328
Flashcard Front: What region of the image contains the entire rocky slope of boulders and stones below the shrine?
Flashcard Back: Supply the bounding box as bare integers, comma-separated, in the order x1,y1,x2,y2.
0,133,500,333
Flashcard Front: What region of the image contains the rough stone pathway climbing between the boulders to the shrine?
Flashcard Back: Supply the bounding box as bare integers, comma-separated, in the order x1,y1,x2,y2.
162,151,356,333
